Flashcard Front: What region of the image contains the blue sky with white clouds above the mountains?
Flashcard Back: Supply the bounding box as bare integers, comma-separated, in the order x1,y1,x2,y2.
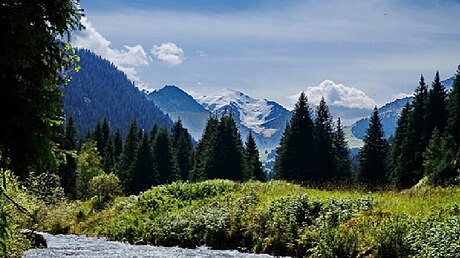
72,0,460,115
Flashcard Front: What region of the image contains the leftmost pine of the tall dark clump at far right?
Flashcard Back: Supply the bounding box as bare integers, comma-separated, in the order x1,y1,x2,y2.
388,103,420,188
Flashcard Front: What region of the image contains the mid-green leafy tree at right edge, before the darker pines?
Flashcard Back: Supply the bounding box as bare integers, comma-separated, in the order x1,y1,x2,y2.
423,128,460,186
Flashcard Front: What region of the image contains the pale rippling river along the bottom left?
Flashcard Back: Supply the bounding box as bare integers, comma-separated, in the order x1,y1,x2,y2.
23,233,272,258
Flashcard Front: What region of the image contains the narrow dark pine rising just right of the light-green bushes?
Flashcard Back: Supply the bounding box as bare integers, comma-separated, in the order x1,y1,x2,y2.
116,120,139,194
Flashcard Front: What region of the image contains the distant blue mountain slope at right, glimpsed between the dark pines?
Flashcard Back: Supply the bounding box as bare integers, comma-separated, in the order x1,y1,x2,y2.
345,77,454,148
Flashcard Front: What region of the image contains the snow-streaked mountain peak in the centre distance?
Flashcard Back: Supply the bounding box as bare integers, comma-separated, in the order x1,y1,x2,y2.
197,89,291,148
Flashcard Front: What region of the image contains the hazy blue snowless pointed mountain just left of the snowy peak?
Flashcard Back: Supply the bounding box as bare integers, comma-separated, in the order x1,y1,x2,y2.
147,85,210,140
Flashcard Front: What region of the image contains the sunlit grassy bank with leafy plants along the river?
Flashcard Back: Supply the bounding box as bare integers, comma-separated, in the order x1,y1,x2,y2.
38,180,460,257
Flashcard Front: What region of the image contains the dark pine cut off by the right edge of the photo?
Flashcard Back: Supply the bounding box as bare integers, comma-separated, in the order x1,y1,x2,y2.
446,65,460,148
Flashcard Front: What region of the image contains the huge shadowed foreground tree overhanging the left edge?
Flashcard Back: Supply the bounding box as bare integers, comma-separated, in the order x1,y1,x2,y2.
0,0,81,180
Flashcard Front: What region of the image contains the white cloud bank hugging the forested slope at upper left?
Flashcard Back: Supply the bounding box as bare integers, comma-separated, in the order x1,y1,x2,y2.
72,17,152,87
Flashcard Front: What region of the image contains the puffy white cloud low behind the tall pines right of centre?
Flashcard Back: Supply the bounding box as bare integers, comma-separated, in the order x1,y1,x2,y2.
290,80,376,109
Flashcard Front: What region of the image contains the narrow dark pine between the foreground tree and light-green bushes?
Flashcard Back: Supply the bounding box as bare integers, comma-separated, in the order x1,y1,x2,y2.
59,117,78,198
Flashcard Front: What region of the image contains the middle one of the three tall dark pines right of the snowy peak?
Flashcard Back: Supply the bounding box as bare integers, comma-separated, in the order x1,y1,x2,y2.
313,97,337,181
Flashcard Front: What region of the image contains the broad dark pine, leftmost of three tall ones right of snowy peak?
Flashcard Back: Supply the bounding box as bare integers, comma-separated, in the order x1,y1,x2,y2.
275,92,318,180
